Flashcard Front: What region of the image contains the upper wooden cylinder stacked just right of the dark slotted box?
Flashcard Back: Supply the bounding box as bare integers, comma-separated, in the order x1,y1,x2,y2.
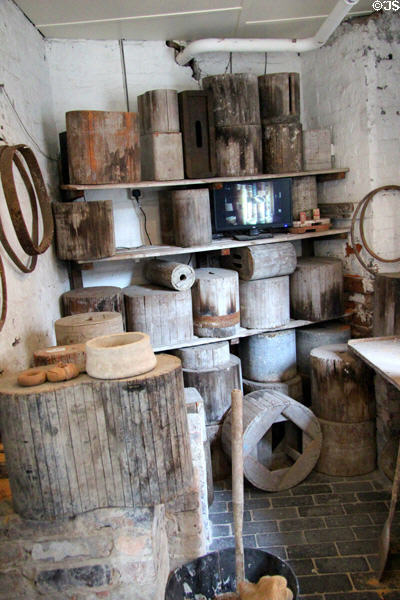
202,73,260,127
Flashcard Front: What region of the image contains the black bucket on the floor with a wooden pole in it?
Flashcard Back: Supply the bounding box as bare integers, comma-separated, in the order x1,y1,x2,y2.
164,548,299,600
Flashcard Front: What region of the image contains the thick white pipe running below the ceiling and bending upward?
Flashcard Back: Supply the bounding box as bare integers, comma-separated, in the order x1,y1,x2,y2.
176,0,358,66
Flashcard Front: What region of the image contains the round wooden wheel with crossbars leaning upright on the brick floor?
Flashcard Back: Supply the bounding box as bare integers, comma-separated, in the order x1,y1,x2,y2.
222,391,322,491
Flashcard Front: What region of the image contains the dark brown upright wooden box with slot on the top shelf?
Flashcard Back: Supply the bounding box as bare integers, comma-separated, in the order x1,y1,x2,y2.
178,90,217,179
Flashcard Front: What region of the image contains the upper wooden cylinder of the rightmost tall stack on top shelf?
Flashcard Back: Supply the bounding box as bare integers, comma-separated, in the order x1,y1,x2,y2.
258,73,300,123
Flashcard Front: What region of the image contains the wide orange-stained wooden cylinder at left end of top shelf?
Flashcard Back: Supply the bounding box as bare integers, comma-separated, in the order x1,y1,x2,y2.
66,110,141,185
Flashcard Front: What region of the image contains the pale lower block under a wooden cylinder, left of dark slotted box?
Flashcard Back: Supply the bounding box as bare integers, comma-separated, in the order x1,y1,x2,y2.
140,133,184,181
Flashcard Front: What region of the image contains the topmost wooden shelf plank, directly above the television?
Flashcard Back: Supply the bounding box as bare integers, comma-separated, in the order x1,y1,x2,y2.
60,167,349,191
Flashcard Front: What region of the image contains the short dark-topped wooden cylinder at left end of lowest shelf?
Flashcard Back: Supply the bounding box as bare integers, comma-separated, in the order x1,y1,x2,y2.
61,285,124,317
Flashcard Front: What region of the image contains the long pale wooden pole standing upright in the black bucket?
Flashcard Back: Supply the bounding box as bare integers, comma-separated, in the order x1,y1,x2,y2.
231,390,244,586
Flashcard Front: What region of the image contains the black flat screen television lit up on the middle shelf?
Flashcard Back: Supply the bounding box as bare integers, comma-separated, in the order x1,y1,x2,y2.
210,177,292,235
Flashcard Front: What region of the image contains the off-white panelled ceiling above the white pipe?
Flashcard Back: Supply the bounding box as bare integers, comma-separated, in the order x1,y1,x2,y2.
15,0,373,40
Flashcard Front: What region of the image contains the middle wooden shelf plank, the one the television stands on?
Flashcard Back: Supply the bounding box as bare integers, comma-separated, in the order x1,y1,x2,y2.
76,227,349,265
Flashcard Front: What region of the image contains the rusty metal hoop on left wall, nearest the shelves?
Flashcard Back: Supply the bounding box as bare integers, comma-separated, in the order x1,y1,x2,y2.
0,144,54,256
